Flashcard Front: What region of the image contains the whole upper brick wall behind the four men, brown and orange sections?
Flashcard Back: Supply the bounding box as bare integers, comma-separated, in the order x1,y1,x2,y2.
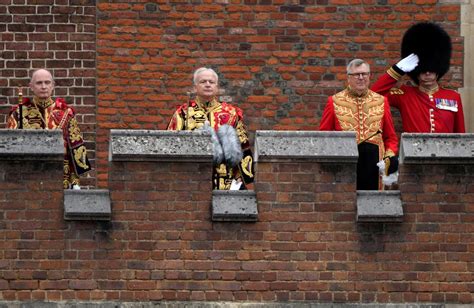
0,0,463,187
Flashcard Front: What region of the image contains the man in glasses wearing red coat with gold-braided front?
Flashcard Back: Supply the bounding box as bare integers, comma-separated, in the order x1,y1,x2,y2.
319,59,398,190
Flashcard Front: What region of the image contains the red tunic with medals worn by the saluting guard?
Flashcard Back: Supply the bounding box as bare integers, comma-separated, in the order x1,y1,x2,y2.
372,68,466,133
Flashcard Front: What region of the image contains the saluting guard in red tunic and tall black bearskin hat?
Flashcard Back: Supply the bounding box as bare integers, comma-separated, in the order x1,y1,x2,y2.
372,23,466,133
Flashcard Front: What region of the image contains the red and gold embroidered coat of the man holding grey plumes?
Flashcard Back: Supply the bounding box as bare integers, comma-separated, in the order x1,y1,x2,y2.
167,99,254,190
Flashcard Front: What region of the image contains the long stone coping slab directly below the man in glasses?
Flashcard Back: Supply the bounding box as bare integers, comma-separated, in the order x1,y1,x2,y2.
255,130,359,163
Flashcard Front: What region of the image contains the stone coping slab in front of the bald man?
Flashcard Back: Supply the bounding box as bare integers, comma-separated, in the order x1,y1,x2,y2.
0,129,64,161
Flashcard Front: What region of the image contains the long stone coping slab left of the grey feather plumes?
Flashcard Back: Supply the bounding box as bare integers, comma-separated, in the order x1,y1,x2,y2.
109,129,213,162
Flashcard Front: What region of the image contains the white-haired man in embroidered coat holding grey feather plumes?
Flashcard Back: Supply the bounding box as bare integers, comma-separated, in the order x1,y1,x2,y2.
168,67,254,190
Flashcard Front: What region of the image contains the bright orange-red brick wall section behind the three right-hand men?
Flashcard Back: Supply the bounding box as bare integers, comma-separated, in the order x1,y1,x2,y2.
97,0,463,186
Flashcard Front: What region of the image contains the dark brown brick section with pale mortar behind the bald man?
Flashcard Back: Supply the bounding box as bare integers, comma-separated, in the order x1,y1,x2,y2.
0,0,96,186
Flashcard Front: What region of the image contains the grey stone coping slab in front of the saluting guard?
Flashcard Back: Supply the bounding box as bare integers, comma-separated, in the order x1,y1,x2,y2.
400,133,474,164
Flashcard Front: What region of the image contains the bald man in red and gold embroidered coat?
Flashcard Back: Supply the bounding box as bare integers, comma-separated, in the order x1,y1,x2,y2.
7,69,91,189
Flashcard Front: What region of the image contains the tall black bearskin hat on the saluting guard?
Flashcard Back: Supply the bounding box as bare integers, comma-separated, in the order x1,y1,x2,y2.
401,22,452,84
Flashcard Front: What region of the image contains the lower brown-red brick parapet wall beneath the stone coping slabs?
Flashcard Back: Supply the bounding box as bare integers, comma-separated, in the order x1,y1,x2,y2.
0,158,474,304
